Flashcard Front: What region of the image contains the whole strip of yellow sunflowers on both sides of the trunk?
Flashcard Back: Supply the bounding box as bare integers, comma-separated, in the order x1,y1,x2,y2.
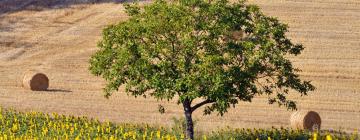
0,108,359,140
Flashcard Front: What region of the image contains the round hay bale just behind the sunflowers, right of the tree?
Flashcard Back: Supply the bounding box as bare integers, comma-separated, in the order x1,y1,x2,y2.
290,111,321,131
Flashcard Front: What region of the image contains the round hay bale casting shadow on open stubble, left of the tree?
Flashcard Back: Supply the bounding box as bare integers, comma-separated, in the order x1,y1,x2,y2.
23,72,49,91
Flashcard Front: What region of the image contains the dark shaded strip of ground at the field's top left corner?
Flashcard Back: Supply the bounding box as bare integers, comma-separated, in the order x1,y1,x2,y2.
0,0,142,16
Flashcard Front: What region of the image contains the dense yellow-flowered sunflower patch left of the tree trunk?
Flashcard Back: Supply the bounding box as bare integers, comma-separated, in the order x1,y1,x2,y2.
0,108,173,140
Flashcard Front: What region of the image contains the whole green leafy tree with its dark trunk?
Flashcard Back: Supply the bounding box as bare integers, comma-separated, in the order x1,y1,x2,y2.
90,0,315,139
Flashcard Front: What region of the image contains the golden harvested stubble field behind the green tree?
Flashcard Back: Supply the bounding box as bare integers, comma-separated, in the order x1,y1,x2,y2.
0,0,360,132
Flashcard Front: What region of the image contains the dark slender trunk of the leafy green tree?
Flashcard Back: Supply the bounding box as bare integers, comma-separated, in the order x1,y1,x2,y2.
183,99,194,140
